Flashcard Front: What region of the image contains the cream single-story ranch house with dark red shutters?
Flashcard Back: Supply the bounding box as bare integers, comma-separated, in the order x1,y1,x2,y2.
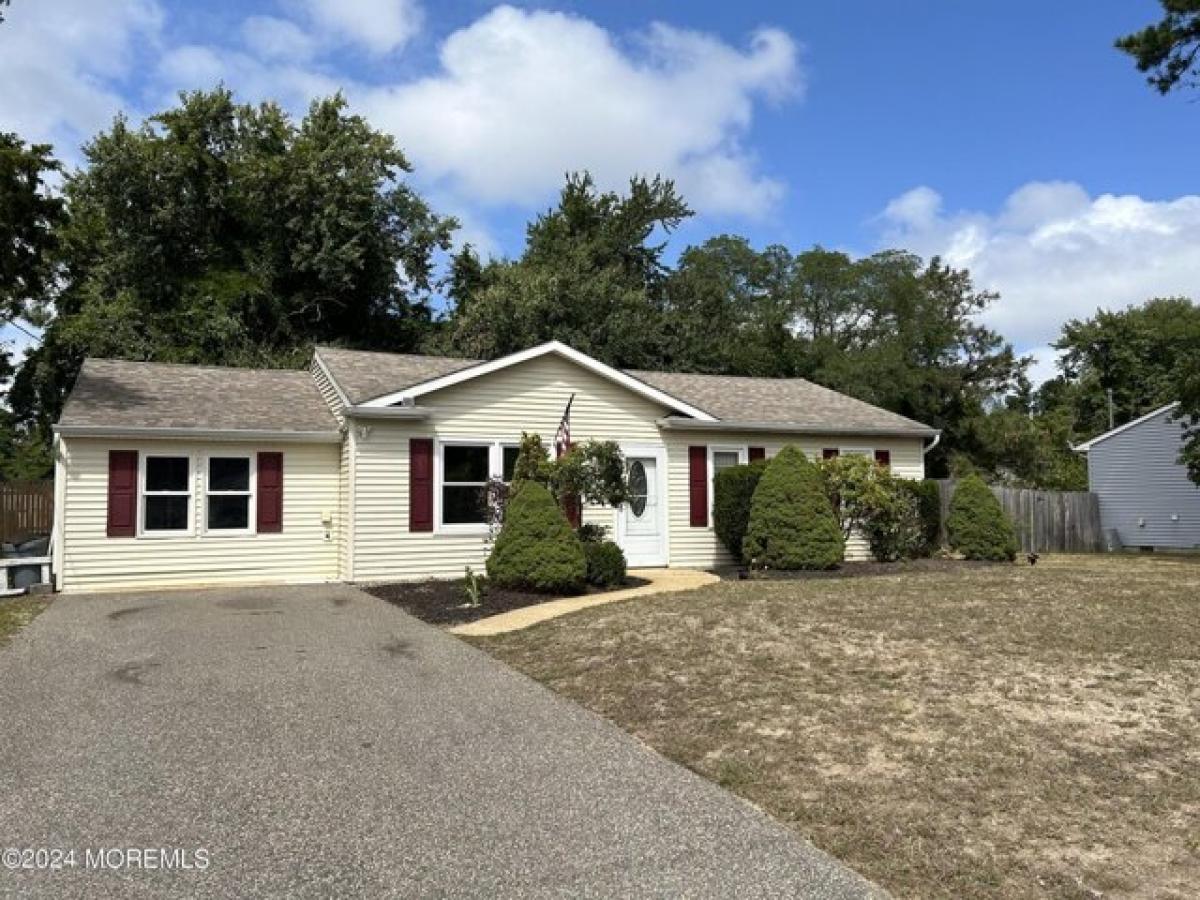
53,342,938,590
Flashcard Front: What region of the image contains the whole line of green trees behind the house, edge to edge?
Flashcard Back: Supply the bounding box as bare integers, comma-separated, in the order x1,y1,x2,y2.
0,89,1200,488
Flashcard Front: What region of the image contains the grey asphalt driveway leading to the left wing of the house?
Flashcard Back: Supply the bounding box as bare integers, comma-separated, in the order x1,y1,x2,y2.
0,586,876,896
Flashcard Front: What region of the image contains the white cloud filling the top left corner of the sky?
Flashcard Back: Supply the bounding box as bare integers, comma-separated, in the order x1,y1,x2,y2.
0,0,163,158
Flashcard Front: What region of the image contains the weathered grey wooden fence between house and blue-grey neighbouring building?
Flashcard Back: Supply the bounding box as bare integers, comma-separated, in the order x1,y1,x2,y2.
937,479,1105,553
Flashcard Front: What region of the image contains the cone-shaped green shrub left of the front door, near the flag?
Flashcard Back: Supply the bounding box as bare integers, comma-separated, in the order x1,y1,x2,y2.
487,481,587,594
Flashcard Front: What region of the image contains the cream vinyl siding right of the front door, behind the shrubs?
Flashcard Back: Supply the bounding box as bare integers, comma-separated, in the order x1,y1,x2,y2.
665,431,925,569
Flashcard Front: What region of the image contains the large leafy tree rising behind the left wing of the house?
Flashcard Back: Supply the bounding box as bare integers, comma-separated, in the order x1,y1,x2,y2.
12,89,454,434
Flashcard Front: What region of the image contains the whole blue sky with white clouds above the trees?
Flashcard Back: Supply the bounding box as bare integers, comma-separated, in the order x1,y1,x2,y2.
0,0,1200,373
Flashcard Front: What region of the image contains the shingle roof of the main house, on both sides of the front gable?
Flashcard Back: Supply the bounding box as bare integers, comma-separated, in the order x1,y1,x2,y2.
318,347,934,434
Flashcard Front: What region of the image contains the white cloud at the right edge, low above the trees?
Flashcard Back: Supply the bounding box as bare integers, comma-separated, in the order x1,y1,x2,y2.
880,181,1200,373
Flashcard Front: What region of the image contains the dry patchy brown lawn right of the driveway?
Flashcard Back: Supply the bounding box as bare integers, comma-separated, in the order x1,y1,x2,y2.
479,557,1200,898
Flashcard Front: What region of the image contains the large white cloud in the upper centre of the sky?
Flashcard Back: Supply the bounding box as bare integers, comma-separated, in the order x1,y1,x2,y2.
352,6,800,216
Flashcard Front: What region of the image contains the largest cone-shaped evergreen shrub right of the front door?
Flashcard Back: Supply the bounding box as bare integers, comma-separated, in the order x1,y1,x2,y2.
743,446,845,569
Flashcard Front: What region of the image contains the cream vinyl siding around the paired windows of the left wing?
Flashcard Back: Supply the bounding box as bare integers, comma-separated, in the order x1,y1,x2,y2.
61,438,338,592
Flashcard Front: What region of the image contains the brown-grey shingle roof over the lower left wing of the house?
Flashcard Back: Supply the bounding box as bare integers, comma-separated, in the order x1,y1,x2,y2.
59,359,337,434
